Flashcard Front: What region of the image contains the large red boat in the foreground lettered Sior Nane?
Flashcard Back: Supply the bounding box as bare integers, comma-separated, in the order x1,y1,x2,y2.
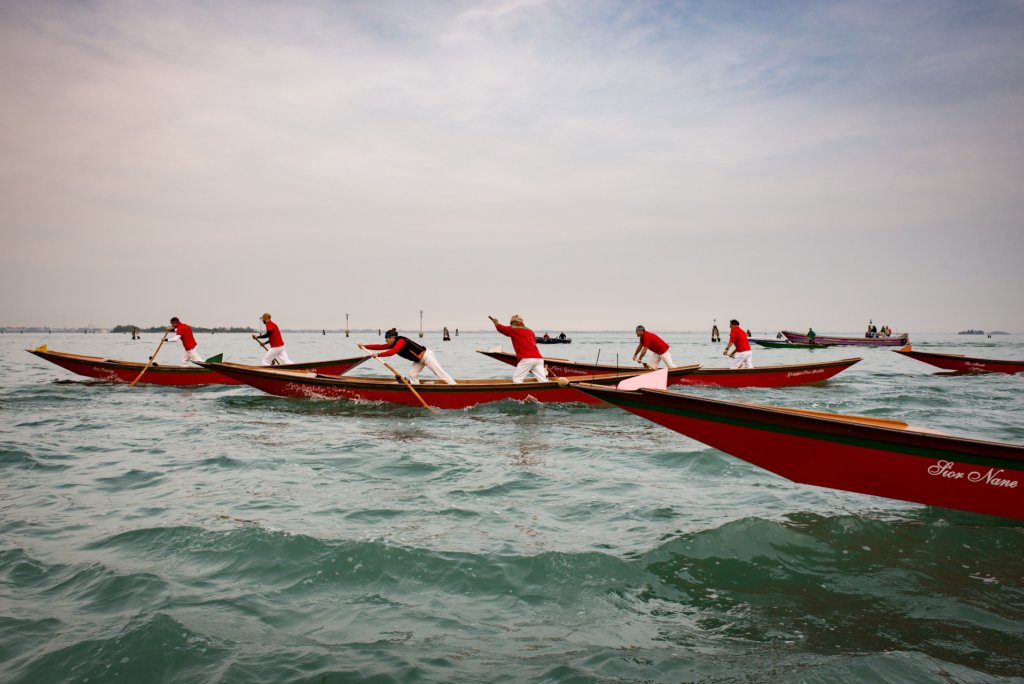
577,383,1024,520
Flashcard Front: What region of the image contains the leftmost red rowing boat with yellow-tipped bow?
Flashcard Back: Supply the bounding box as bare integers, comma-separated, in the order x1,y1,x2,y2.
26,345,370,385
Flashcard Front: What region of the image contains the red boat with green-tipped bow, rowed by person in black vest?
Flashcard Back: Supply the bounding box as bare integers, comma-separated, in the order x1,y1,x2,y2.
195,362,698,409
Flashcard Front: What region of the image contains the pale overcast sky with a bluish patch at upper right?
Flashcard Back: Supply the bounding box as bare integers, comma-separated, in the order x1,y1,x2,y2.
0,0,1024,334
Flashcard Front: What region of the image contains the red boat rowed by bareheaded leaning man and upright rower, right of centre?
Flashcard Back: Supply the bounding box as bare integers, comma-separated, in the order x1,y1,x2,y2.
477,349,861,387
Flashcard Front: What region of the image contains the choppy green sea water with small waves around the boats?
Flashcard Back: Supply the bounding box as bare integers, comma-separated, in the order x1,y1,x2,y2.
0,331,1024,682
